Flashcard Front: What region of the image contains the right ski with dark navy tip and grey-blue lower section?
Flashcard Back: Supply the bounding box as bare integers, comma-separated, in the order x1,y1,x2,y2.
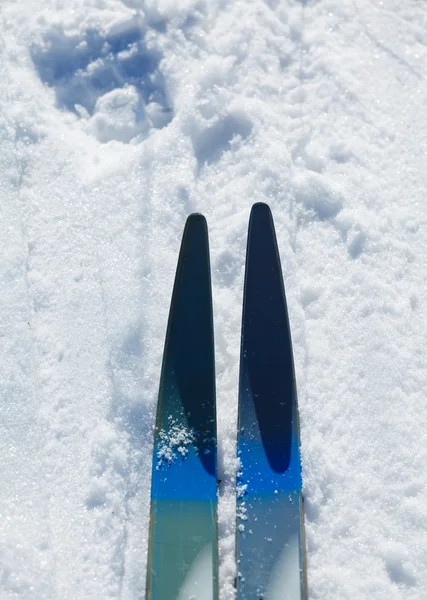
236,203,307,600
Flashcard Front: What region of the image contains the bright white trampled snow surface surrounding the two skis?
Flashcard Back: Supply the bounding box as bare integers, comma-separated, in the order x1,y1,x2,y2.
0,0,427,600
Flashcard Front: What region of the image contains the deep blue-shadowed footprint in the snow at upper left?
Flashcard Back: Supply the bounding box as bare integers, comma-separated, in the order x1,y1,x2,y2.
31,17,173,143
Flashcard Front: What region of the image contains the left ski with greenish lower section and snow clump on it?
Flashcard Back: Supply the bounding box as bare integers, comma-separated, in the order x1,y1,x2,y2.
146,214,218,600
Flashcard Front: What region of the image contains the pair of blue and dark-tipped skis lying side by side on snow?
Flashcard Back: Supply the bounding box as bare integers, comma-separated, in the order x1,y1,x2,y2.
147,203,307,600
